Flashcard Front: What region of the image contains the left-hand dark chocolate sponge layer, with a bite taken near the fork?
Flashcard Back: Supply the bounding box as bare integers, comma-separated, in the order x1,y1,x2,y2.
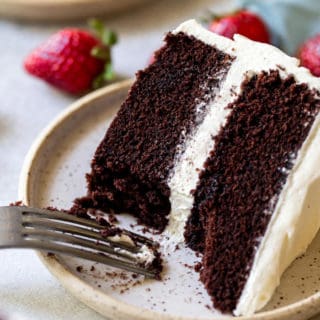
87,33,232,230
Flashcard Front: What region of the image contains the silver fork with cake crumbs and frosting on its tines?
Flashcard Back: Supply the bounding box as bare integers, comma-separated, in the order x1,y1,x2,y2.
0,206,159,278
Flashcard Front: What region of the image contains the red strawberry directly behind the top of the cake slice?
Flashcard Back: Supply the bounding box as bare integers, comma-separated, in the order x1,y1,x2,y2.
209,10,270,43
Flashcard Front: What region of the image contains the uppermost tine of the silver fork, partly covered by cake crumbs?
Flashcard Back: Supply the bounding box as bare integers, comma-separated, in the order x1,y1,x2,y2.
17,207,156,246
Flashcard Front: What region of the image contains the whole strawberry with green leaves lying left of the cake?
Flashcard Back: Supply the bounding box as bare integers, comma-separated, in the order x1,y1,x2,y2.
24,20,116,94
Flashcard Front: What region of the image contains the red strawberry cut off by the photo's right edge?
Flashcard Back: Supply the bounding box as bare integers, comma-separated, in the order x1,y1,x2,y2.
298,34,320,77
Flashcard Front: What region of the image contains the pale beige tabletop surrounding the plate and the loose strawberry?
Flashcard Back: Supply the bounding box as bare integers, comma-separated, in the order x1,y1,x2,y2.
0,0,320,320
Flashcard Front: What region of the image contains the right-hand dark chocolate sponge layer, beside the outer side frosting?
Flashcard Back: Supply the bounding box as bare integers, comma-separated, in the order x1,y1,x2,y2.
185,71,320,312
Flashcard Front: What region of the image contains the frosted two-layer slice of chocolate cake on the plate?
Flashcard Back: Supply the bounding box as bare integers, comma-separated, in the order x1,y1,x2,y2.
80,21,320,315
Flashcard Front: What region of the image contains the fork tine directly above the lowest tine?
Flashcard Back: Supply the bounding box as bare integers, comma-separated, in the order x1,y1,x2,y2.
23,228,139,260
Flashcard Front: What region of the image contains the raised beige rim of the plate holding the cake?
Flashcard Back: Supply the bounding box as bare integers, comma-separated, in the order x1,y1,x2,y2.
18,79,320,320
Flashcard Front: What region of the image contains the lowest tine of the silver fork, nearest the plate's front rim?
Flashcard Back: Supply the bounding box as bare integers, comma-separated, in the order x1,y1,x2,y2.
20,240,157,278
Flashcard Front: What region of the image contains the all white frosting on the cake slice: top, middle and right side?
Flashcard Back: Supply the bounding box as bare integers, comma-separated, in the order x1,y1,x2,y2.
166,20,320,315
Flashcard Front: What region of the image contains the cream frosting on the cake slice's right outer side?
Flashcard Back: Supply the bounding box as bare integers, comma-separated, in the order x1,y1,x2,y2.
234,112,320,315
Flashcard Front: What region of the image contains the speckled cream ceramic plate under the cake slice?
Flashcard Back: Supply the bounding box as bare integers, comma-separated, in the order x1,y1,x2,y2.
20,81,320,320
